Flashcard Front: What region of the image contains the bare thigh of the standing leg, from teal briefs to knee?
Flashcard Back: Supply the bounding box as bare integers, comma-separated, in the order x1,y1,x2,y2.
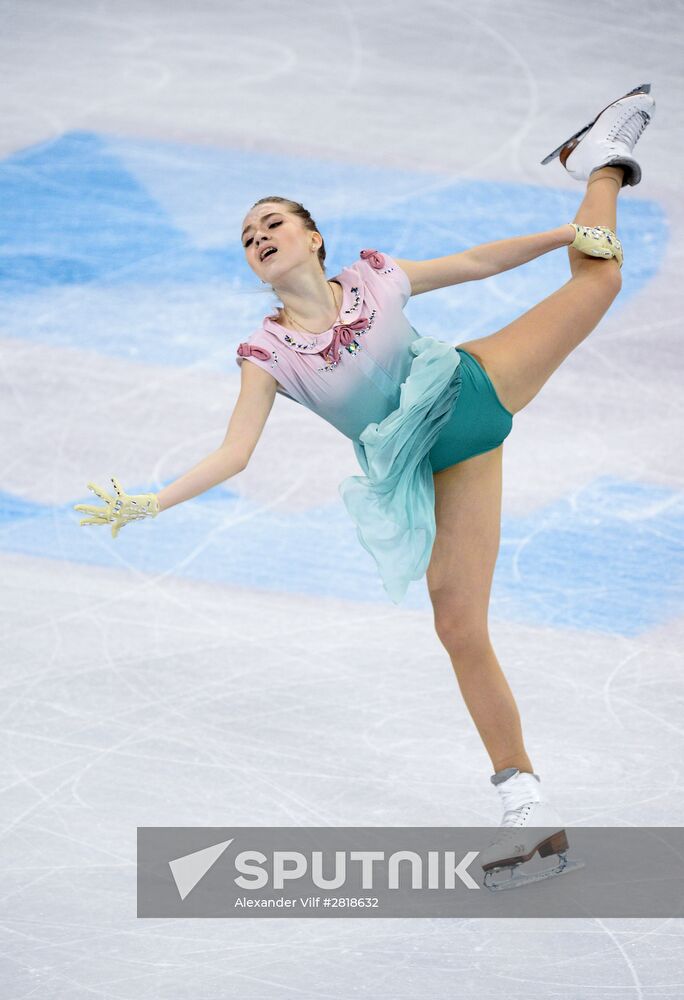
426,445,503,642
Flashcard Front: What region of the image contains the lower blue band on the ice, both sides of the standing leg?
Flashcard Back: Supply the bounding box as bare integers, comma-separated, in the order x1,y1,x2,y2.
0,477,684,636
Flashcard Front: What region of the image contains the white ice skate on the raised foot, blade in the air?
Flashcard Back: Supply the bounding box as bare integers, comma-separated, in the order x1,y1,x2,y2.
542,83,655,187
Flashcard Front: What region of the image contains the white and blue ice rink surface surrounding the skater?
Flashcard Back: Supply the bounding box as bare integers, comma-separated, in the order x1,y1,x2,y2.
0,0,684,1000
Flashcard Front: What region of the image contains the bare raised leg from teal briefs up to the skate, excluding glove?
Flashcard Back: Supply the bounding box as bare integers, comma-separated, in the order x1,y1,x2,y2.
458,167,622,413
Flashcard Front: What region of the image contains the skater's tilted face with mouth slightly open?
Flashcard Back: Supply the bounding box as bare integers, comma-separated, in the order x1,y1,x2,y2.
242,202,321,285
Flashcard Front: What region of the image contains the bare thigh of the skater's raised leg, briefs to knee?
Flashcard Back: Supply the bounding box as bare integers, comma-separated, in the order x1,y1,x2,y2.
457,261,620,413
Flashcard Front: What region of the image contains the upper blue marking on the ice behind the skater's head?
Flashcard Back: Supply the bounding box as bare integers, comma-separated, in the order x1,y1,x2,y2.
0,132,667,376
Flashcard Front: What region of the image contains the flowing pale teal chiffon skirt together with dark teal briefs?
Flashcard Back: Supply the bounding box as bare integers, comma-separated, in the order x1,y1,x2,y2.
339,337,513,604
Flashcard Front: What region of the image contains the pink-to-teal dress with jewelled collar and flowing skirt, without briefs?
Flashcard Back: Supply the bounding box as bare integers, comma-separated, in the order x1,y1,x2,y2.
236,250,461,604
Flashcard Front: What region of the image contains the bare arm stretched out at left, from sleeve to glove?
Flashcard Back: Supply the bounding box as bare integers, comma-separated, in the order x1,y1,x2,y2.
157,364,276,510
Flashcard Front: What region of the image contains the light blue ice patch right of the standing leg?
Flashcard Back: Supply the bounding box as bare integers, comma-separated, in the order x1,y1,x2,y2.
492,476,684,636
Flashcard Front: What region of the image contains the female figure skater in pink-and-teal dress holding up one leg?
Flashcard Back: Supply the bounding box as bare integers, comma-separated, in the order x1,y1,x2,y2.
75,84,655,888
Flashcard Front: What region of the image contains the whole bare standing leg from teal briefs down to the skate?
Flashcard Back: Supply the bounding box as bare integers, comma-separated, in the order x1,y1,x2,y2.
427,446,533,772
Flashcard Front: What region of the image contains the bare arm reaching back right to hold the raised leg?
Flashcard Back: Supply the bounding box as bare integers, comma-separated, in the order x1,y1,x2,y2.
397,224,575,295
